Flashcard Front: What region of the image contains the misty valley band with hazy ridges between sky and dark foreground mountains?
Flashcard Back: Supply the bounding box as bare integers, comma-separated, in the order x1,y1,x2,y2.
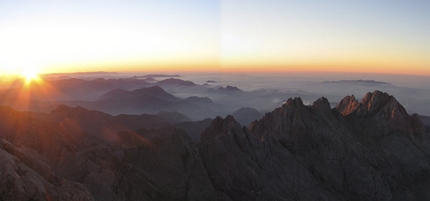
0,72,430,126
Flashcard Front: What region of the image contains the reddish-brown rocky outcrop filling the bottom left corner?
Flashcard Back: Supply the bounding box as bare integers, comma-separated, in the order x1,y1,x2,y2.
0,139,93,200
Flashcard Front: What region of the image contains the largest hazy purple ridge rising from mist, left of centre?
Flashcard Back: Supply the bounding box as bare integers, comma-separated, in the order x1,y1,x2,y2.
61,86,223,120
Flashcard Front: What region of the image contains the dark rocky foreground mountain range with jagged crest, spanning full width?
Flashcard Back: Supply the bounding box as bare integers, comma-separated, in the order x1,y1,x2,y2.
0,91,430,200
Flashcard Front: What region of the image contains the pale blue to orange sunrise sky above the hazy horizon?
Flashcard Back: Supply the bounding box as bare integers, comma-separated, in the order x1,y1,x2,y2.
0,0,430,75
